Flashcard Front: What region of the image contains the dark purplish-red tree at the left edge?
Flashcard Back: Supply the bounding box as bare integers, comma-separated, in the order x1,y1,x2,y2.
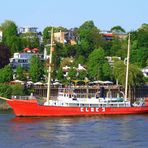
0,45,10,68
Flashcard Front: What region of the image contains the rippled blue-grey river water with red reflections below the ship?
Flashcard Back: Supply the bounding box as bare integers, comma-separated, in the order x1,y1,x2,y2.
0,112,148,148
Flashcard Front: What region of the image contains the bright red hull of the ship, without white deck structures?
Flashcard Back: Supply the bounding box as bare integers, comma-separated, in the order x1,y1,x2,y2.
7,99,148,117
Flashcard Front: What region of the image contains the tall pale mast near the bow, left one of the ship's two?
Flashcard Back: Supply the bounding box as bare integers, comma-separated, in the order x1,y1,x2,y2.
47,28,53,105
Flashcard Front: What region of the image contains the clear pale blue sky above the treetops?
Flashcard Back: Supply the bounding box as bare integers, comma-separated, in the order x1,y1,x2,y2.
0,0,148,32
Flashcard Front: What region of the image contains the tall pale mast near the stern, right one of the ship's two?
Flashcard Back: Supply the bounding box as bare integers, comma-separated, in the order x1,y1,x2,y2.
125,33,130,99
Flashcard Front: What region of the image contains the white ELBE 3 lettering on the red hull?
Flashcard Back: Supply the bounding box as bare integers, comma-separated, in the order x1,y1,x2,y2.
80,107,105,113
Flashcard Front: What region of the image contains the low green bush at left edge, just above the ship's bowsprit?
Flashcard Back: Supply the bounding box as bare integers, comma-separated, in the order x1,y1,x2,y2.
0,83,12,98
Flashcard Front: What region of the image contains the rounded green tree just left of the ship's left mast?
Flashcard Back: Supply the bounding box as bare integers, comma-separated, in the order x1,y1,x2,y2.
29,56,44,82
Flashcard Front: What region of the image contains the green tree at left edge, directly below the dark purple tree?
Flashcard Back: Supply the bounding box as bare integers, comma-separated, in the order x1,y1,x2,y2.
0,65,13,83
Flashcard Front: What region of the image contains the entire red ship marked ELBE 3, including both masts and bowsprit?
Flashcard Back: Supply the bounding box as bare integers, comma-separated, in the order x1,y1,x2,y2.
0,30,148,117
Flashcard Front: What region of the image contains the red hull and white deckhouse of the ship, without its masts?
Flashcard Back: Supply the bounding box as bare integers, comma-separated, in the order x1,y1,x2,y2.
2,95,148,117
